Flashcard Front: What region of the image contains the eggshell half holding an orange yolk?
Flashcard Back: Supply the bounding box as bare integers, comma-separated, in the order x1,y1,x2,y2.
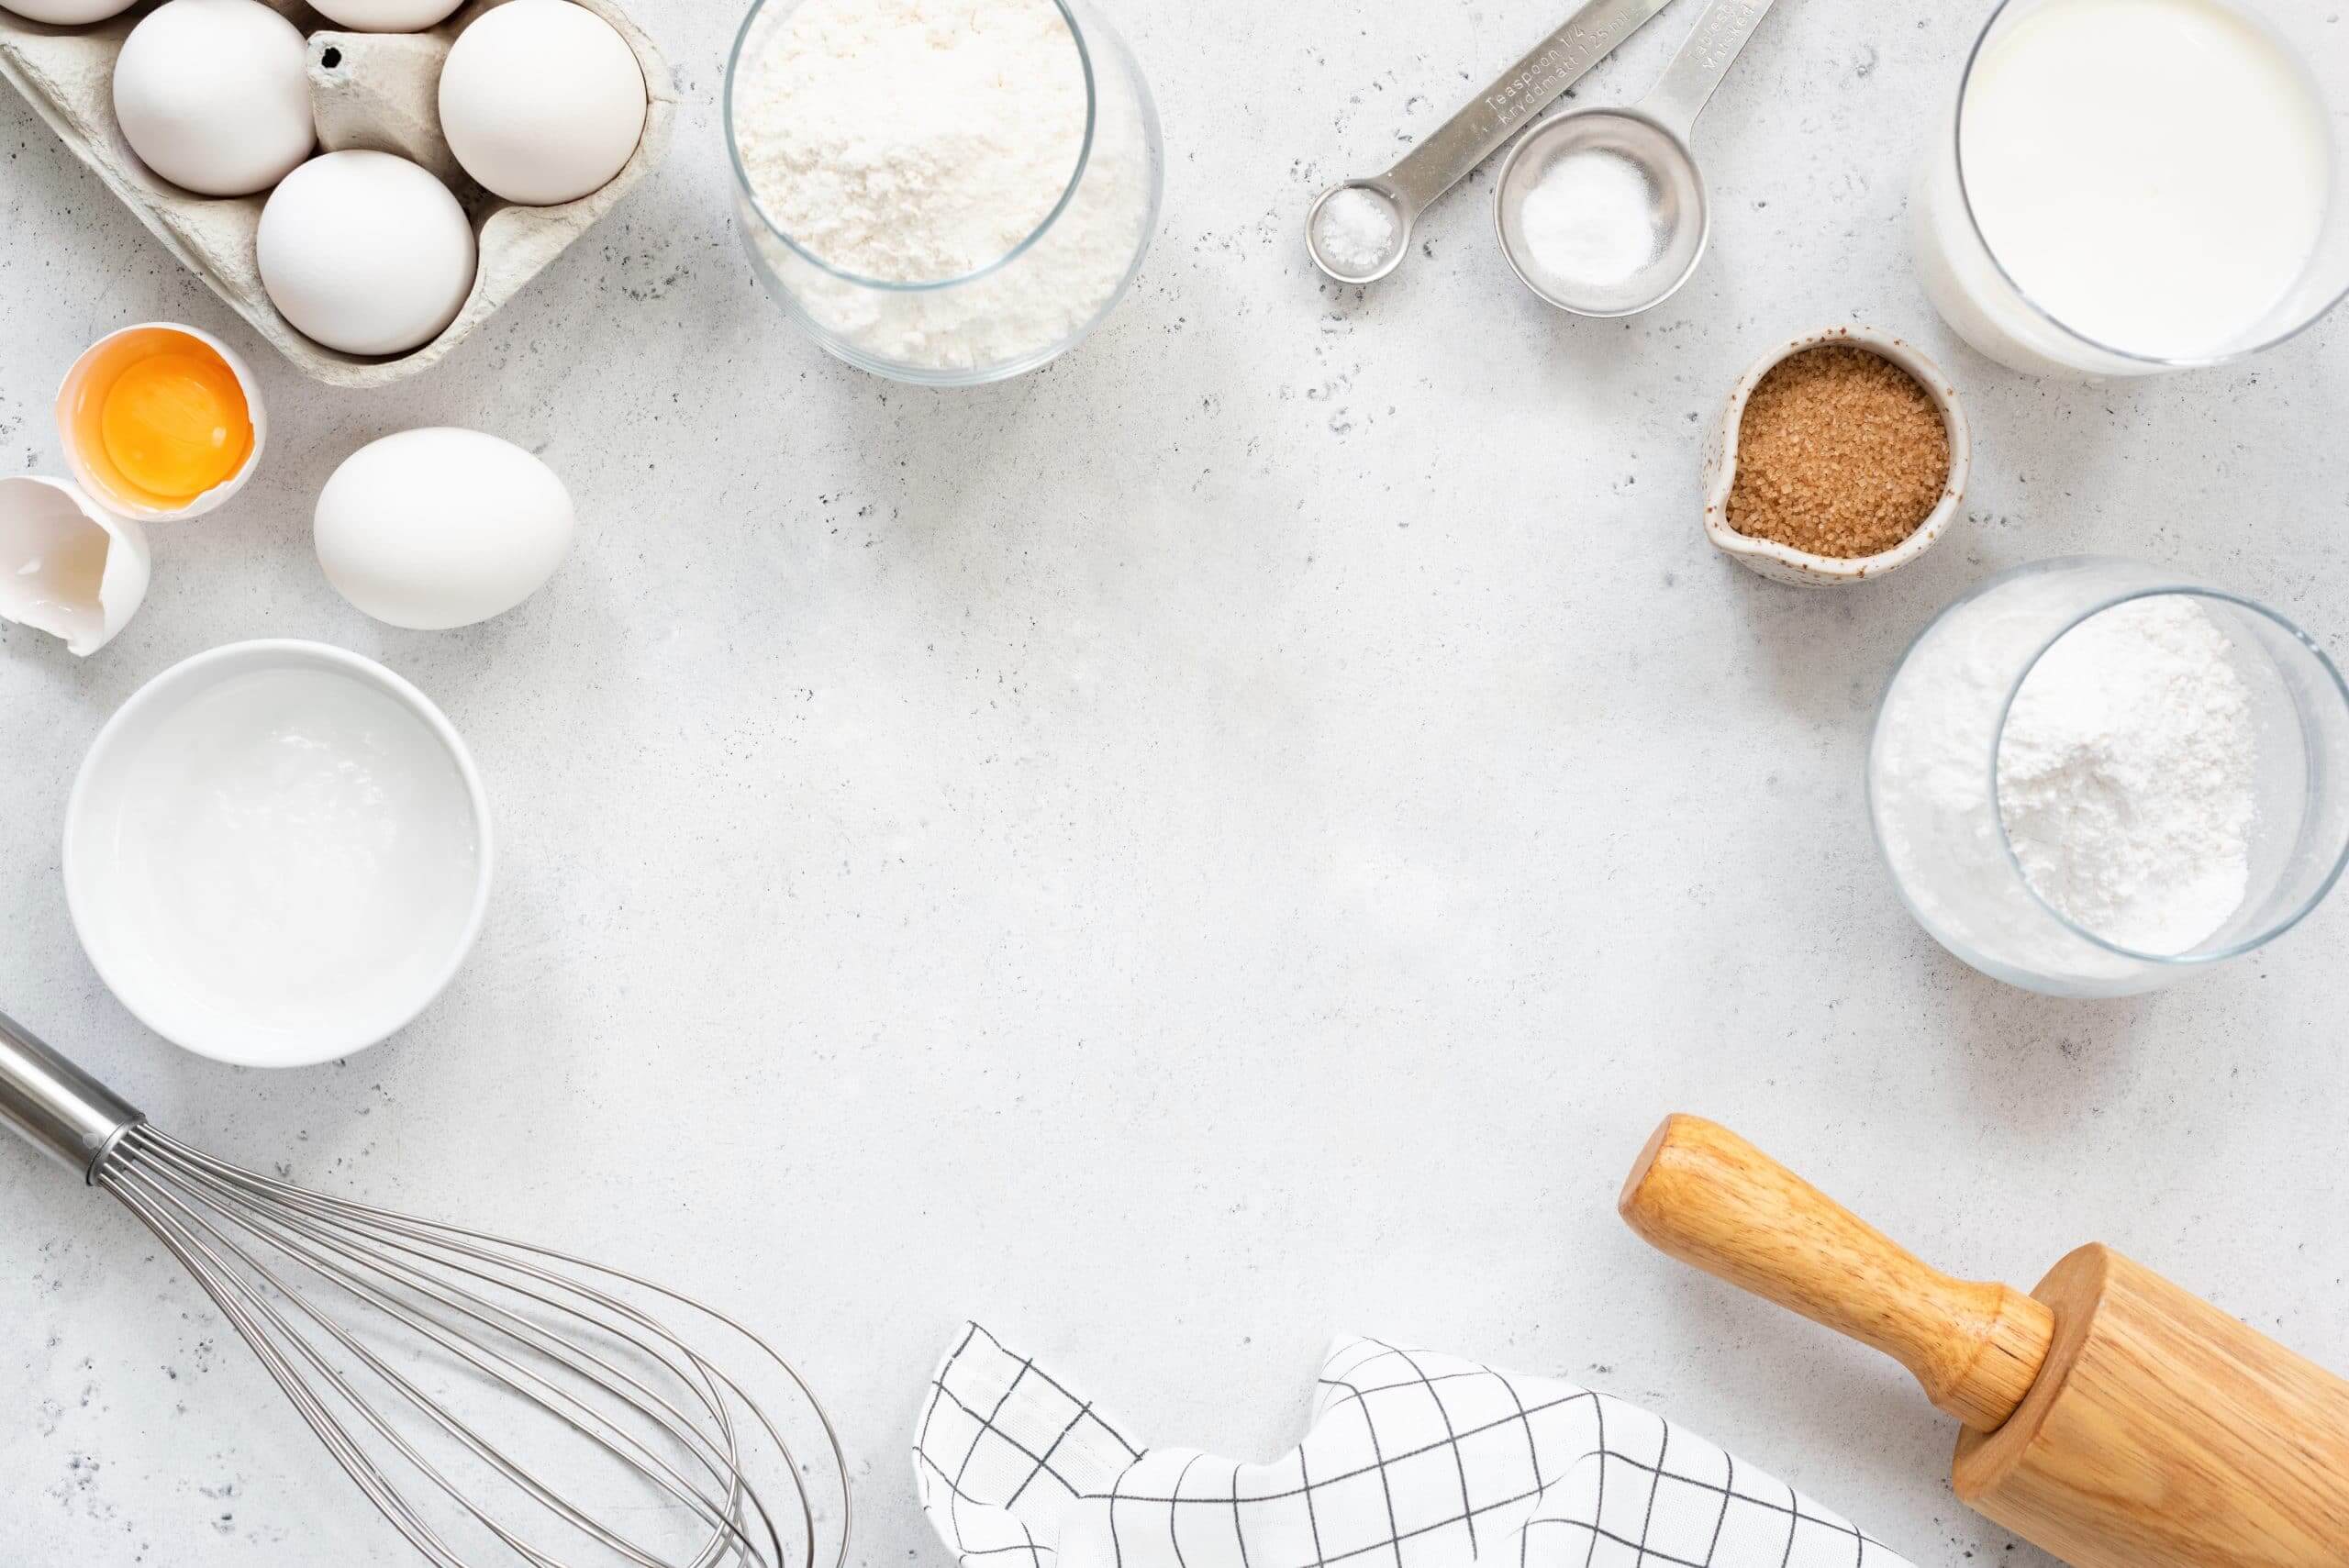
56,321,270,524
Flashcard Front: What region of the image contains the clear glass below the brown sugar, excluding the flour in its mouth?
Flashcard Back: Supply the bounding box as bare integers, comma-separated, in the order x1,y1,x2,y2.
1867,556,2349,997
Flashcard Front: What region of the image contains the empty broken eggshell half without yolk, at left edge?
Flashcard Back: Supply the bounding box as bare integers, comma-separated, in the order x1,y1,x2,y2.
0,474,152,660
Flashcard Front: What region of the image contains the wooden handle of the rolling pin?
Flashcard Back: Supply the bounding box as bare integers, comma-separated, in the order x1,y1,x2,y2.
1619,1115,2055,1432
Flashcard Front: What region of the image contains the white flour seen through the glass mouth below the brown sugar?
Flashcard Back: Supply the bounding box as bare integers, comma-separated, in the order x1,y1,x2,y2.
1999,596,2257,953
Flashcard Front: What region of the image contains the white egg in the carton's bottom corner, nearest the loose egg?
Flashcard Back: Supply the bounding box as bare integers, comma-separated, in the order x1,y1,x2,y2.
258,152,477,354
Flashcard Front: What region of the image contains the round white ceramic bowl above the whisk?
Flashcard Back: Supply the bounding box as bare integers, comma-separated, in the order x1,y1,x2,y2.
63,640,494,1068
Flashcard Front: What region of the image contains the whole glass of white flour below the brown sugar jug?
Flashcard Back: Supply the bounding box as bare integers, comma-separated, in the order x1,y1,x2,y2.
1867,556,2349,997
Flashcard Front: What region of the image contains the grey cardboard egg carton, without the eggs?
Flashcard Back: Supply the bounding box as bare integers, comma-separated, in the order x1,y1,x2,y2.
0,0,676,387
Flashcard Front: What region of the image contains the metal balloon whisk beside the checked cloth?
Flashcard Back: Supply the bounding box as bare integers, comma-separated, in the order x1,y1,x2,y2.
0,1017,848,1568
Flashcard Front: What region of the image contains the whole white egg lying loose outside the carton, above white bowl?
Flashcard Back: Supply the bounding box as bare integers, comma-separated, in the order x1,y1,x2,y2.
317,429,573,631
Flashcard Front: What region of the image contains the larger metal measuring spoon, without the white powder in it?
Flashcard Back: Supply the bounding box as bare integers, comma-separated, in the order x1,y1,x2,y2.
1494,0,1771,317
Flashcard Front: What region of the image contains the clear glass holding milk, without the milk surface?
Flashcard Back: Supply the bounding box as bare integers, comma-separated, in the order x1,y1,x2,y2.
1909,0,2349,378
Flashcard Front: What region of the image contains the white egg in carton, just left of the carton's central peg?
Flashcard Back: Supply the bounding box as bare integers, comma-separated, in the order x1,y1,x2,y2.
115,0,317,195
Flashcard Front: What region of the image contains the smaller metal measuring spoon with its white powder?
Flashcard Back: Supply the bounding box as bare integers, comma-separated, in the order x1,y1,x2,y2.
1306,0,1670,284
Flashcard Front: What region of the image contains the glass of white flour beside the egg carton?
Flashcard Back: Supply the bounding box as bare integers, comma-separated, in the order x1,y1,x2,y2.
726,0,1165,387
